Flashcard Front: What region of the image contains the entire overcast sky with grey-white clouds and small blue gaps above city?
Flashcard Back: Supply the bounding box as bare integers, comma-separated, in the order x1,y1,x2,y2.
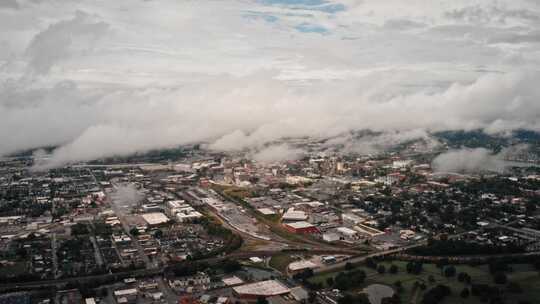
0,0,540,164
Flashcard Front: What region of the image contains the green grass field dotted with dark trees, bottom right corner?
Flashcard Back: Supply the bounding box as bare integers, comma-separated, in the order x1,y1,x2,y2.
310,261,540,304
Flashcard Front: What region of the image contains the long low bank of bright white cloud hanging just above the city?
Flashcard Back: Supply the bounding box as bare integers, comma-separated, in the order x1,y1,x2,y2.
6,69,540,166
